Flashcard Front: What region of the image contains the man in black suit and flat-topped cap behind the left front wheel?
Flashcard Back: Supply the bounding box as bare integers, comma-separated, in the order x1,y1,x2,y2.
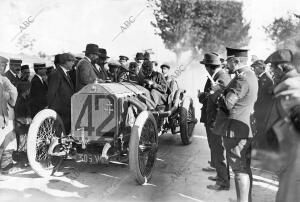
29,63,48,118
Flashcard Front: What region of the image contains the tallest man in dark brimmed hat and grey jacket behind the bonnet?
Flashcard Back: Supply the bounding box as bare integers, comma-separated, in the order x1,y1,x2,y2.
76,44,99,92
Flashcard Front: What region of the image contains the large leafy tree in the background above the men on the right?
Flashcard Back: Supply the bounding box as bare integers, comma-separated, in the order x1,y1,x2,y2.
148,0,250,60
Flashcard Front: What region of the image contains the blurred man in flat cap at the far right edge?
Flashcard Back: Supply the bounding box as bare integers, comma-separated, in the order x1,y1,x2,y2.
254,49,300,202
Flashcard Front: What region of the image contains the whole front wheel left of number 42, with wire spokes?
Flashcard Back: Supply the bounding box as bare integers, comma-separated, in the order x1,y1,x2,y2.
27,109,65,177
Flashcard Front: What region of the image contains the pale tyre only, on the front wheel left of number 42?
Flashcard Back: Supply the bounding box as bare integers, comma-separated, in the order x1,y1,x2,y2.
27,109,65,178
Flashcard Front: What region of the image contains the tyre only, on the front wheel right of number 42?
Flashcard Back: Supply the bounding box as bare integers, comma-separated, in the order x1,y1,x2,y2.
129,111,158,185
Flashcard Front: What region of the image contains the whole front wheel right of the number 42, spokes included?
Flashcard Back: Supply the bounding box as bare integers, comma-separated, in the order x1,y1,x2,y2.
129,111,158,184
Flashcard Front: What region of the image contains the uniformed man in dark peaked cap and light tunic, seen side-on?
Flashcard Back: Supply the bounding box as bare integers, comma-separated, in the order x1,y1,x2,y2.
216,48,258,202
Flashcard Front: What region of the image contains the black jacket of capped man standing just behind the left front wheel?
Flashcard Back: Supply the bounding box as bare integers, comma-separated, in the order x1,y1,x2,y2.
29,75,48,118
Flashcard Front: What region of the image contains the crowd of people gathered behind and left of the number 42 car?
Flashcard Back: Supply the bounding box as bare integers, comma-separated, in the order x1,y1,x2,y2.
0,44,175,179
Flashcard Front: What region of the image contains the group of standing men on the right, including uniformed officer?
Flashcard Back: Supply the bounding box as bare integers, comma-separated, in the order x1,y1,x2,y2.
198,48,300,202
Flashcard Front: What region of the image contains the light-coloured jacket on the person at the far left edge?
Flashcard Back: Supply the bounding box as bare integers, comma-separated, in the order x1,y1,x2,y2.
0,75,18,129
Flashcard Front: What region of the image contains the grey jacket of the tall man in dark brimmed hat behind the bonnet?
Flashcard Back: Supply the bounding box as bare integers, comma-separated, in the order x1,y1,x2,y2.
76,57,99,91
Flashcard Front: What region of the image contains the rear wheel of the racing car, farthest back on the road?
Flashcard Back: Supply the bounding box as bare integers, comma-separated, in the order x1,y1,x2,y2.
179,98,197,145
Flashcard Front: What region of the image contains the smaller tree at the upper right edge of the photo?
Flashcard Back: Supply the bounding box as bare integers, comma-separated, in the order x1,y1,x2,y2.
264,14,300,50
